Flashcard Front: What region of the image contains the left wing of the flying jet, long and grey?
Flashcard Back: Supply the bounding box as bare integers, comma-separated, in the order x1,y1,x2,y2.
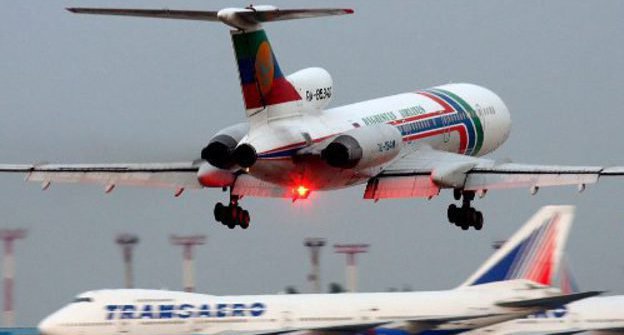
0,162,202,190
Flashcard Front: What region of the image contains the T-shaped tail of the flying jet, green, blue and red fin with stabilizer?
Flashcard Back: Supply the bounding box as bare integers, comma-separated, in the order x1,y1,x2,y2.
67,6,353,116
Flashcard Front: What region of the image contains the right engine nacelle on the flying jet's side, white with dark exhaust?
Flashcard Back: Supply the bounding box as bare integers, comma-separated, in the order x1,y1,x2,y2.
321,124,403,170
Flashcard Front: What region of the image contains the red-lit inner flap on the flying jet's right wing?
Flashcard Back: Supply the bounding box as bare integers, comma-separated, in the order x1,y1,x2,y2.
364,174,440,200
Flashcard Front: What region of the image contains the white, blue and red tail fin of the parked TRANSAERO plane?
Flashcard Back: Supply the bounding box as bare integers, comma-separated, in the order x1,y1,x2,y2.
461,206,574,286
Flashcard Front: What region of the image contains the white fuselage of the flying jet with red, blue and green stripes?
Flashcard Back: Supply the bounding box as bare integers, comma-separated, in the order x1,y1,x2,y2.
241,84,511,190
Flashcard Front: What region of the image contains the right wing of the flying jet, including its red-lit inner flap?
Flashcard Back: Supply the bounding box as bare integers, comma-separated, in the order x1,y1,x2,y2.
364,148,624,200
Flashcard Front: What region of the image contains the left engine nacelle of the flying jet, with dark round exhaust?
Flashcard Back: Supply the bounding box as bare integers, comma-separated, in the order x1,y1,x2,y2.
201,122,249,169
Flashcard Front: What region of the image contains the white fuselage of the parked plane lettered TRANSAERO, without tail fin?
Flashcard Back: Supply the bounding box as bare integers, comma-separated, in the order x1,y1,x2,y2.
39,281,548,335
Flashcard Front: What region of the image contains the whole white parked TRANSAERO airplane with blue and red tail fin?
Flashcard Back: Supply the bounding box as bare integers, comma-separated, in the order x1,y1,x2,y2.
39,206,599,335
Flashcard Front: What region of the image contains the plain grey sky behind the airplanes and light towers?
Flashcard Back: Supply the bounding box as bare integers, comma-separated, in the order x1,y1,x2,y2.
0,0,624,325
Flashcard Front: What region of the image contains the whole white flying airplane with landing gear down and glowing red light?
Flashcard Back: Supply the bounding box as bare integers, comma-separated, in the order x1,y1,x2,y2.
0,6,624,230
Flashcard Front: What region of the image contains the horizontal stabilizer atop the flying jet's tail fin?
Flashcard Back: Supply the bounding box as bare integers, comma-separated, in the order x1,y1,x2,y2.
67,6,353,29
